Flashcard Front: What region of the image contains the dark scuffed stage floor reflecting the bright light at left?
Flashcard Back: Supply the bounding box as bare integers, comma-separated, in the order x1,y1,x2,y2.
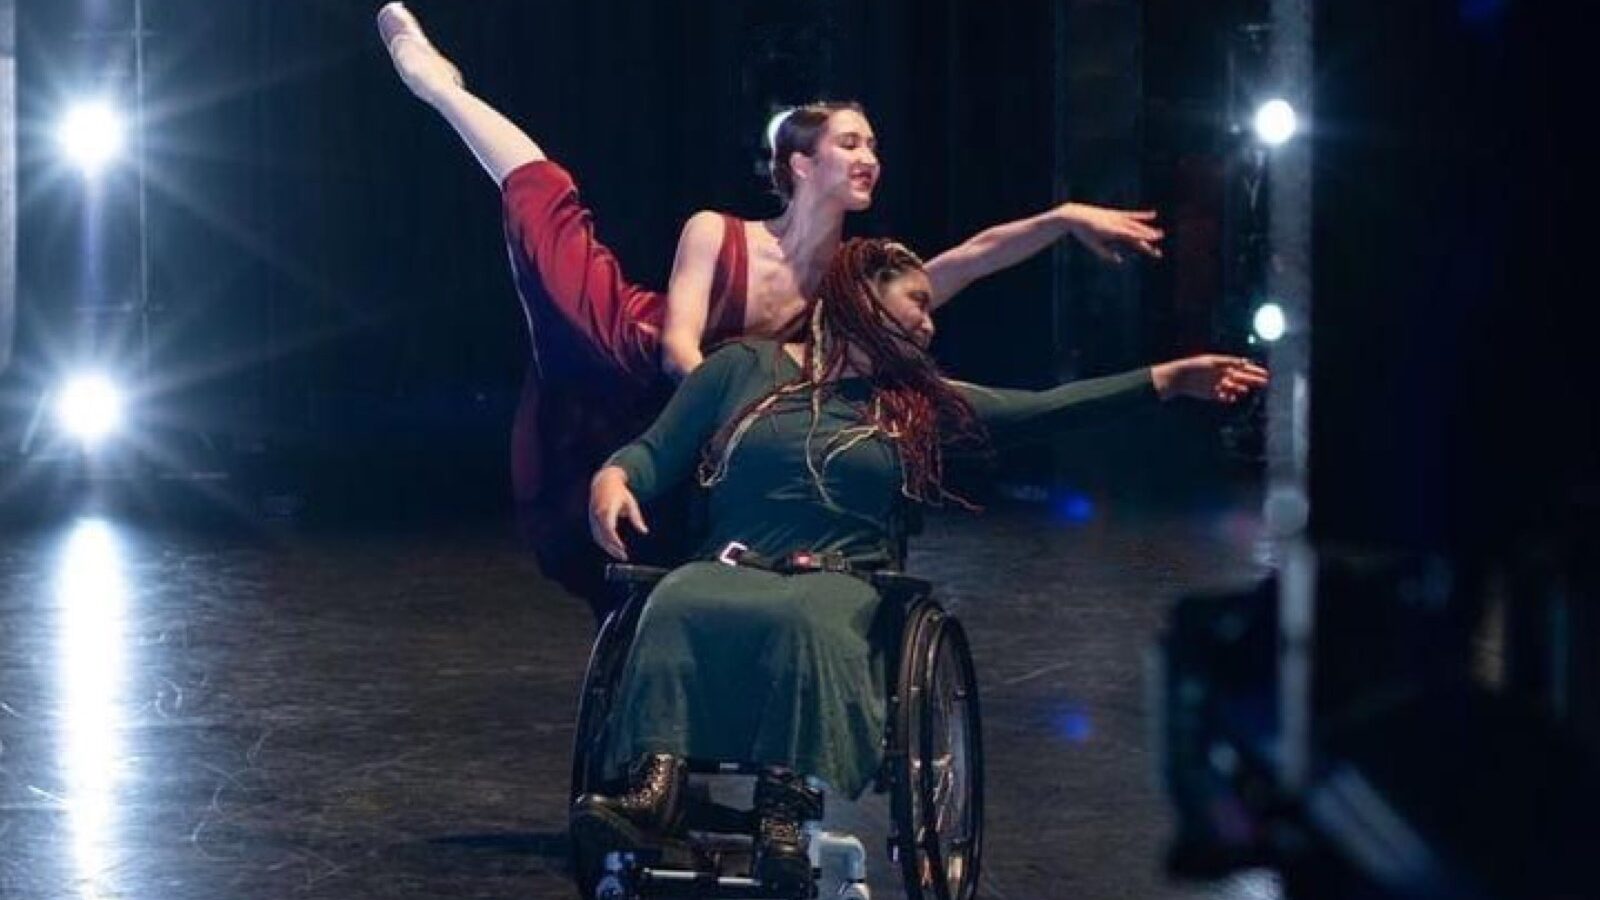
0,496,1277,900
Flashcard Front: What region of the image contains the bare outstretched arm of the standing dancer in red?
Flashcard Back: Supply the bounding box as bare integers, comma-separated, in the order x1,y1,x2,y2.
926,203,1165,307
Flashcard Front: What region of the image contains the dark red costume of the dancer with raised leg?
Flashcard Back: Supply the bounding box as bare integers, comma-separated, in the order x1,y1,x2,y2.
501,160,749,612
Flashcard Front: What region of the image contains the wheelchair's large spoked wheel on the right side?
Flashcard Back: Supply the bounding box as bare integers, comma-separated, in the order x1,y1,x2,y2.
890,604,984,900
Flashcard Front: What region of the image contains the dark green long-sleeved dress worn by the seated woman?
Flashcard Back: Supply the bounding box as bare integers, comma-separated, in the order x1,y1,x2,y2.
606,341,1157,796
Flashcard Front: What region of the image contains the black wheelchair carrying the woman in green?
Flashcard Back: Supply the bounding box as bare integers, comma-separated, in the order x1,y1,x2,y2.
570,565,984,900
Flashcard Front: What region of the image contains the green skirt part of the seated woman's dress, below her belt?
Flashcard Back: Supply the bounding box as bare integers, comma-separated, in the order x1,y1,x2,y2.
606,562,899,798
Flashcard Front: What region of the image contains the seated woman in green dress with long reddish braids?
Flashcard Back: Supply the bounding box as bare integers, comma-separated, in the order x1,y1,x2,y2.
573,240,1267,884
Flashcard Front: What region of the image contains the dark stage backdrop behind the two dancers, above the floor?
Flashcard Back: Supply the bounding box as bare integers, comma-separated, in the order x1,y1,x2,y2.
3,0,1245,518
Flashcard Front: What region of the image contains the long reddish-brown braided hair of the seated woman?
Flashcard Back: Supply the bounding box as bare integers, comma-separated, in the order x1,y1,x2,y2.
699,239,987,509
